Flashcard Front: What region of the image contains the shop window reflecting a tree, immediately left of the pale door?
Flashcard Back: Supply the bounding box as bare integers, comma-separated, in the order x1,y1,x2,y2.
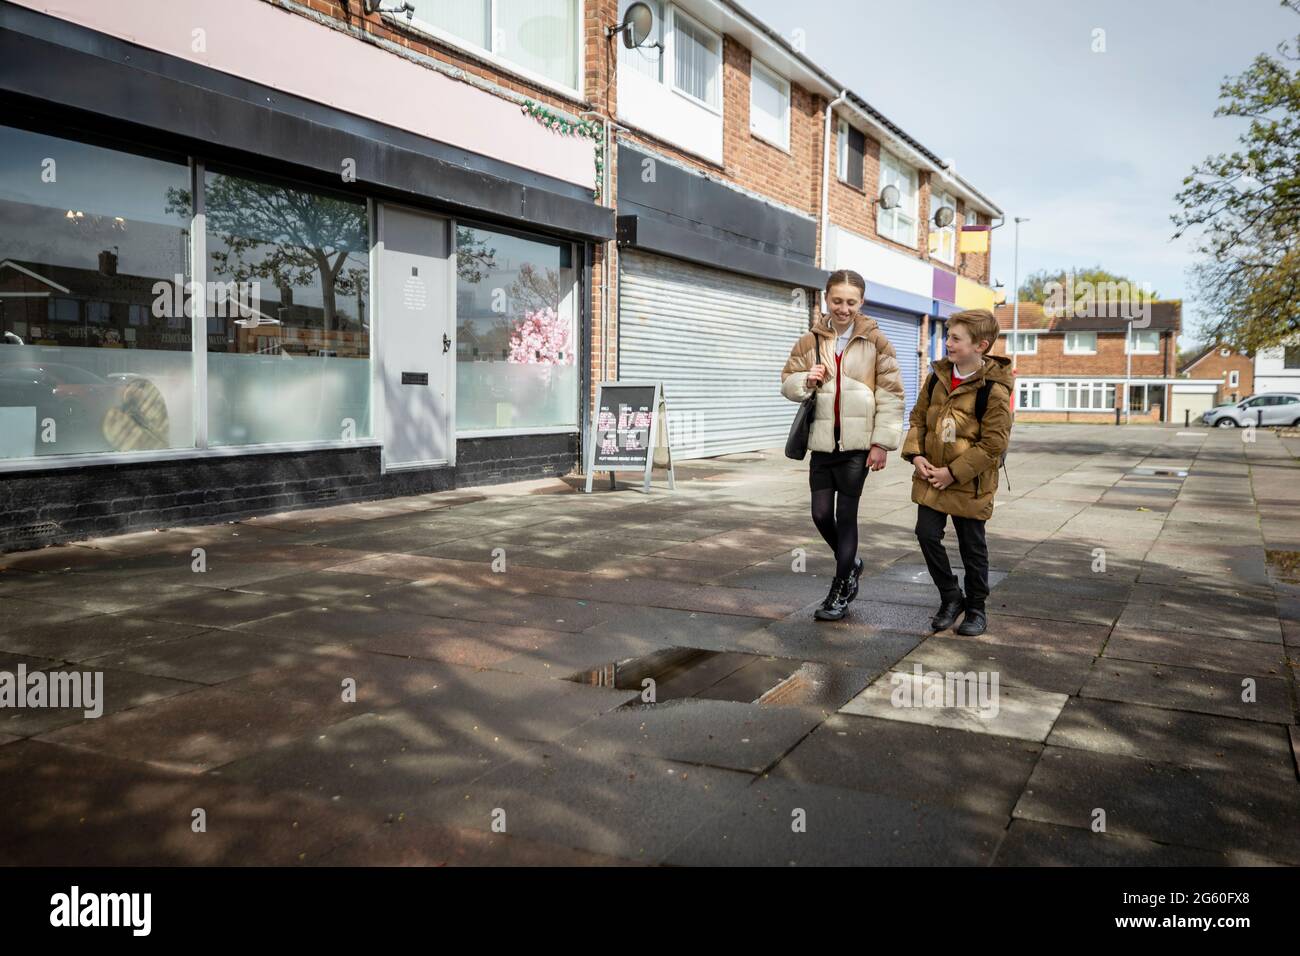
204,172,371,445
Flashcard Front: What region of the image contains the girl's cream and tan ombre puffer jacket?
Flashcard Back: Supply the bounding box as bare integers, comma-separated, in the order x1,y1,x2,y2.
781,313,904,451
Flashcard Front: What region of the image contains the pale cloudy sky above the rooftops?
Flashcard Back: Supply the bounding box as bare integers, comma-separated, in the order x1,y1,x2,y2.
740,0,1300,345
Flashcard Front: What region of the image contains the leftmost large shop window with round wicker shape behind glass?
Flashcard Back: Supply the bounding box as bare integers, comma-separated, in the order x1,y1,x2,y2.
0,126,194,459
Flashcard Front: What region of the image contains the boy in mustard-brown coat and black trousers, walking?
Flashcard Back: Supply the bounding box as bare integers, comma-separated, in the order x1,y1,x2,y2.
902,308,1011,636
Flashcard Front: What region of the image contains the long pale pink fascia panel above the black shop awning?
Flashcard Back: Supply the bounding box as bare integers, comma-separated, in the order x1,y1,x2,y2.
13,0,595,187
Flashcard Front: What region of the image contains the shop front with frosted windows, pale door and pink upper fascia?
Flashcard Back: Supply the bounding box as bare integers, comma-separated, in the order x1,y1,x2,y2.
0,0,614,549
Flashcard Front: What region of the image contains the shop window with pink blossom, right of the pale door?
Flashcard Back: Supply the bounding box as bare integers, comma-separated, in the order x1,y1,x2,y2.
456,225,579,432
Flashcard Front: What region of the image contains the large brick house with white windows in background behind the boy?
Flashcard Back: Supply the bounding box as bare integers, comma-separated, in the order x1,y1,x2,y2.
992,300,1190,423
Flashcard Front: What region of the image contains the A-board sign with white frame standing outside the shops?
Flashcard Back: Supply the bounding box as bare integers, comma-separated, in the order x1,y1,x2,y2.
586,382,675,492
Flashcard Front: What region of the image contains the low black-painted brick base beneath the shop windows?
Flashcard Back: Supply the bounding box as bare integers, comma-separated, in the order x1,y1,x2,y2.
0,432,579,553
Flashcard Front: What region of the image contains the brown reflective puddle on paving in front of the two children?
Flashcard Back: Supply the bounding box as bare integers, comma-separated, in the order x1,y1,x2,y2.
567,648,871,709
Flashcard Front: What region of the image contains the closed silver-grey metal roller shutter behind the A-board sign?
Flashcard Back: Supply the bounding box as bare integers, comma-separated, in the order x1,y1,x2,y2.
619,248,814,458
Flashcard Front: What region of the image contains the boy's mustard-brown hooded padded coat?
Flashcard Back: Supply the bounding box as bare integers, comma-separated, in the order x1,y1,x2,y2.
902,355,1011,522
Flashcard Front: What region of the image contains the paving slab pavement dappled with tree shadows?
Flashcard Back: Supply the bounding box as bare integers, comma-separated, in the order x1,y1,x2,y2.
0,425,1300,866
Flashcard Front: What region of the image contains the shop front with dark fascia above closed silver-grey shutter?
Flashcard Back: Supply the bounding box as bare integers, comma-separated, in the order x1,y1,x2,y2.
618,143,828,459
